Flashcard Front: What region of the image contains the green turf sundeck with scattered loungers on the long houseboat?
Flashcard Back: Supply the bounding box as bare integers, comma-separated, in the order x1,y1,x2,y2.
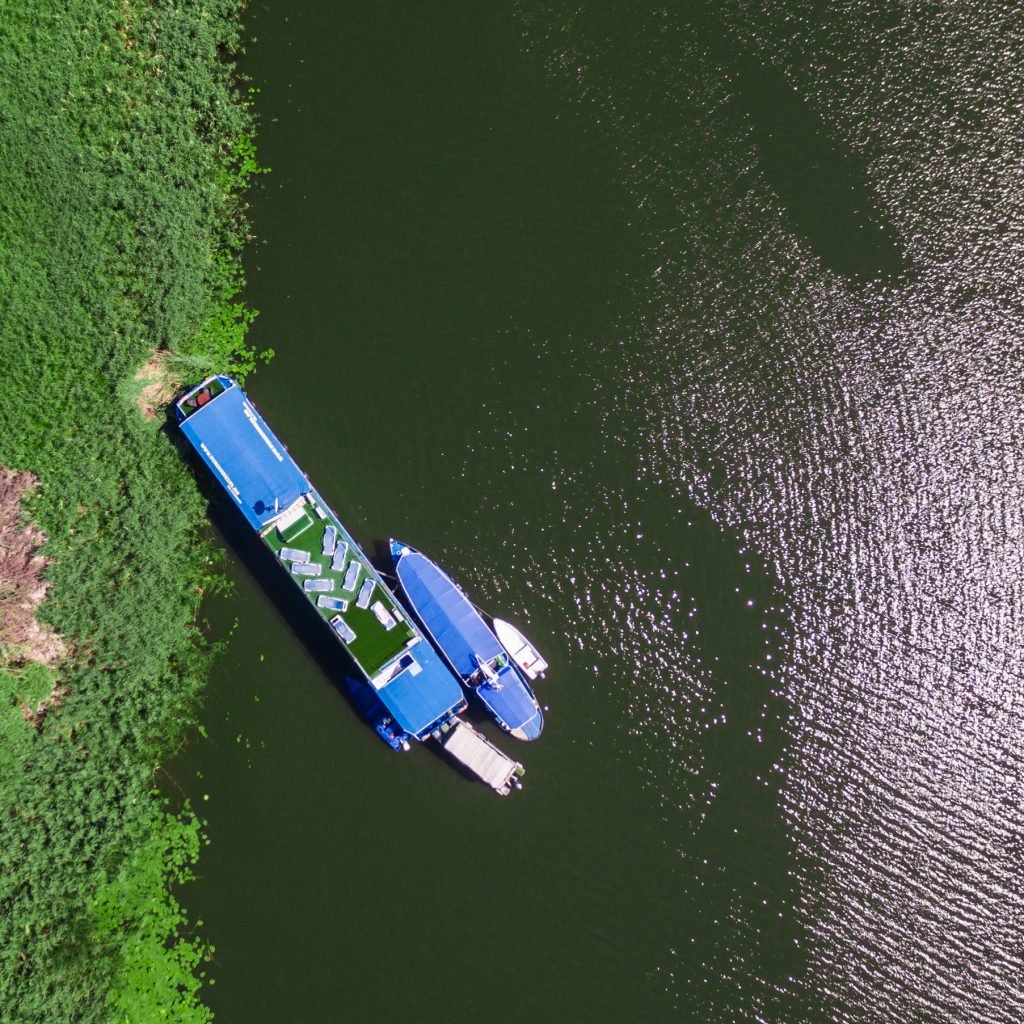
261,492,416,679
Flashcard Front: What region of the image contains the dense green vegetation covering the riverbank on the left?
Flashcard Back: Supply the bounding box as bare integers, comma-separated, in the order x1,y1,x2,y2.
0,0,264,1024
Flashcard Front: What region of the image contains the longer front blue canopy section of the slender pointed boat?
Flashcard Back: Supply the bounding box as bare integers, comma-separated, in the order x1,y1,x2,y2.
395,550,504,679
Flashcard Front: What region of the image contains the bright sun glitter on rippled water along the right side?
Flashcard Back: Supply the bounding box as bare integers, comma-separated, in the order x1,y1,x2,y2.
527,4,1024,1024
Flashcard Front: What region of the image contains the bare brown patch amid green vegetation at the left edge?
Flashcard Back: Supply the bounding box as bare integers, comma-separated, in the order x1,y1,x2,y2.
0,467,67,725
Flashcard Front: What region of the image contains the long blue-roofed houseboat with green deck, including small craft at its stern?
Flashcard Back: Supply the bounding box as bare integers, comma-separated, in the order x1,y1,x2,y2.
174,376,522,794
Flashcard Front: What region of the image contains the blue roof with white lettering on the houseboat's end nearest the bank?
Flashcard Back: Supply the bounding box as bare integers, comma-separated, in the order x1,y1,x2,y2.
181,377,310,530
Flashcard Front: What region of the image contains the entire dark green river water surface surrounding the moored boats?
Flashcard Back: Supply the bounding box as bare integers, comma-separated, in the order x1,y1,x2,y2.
171,2,1024,1024
